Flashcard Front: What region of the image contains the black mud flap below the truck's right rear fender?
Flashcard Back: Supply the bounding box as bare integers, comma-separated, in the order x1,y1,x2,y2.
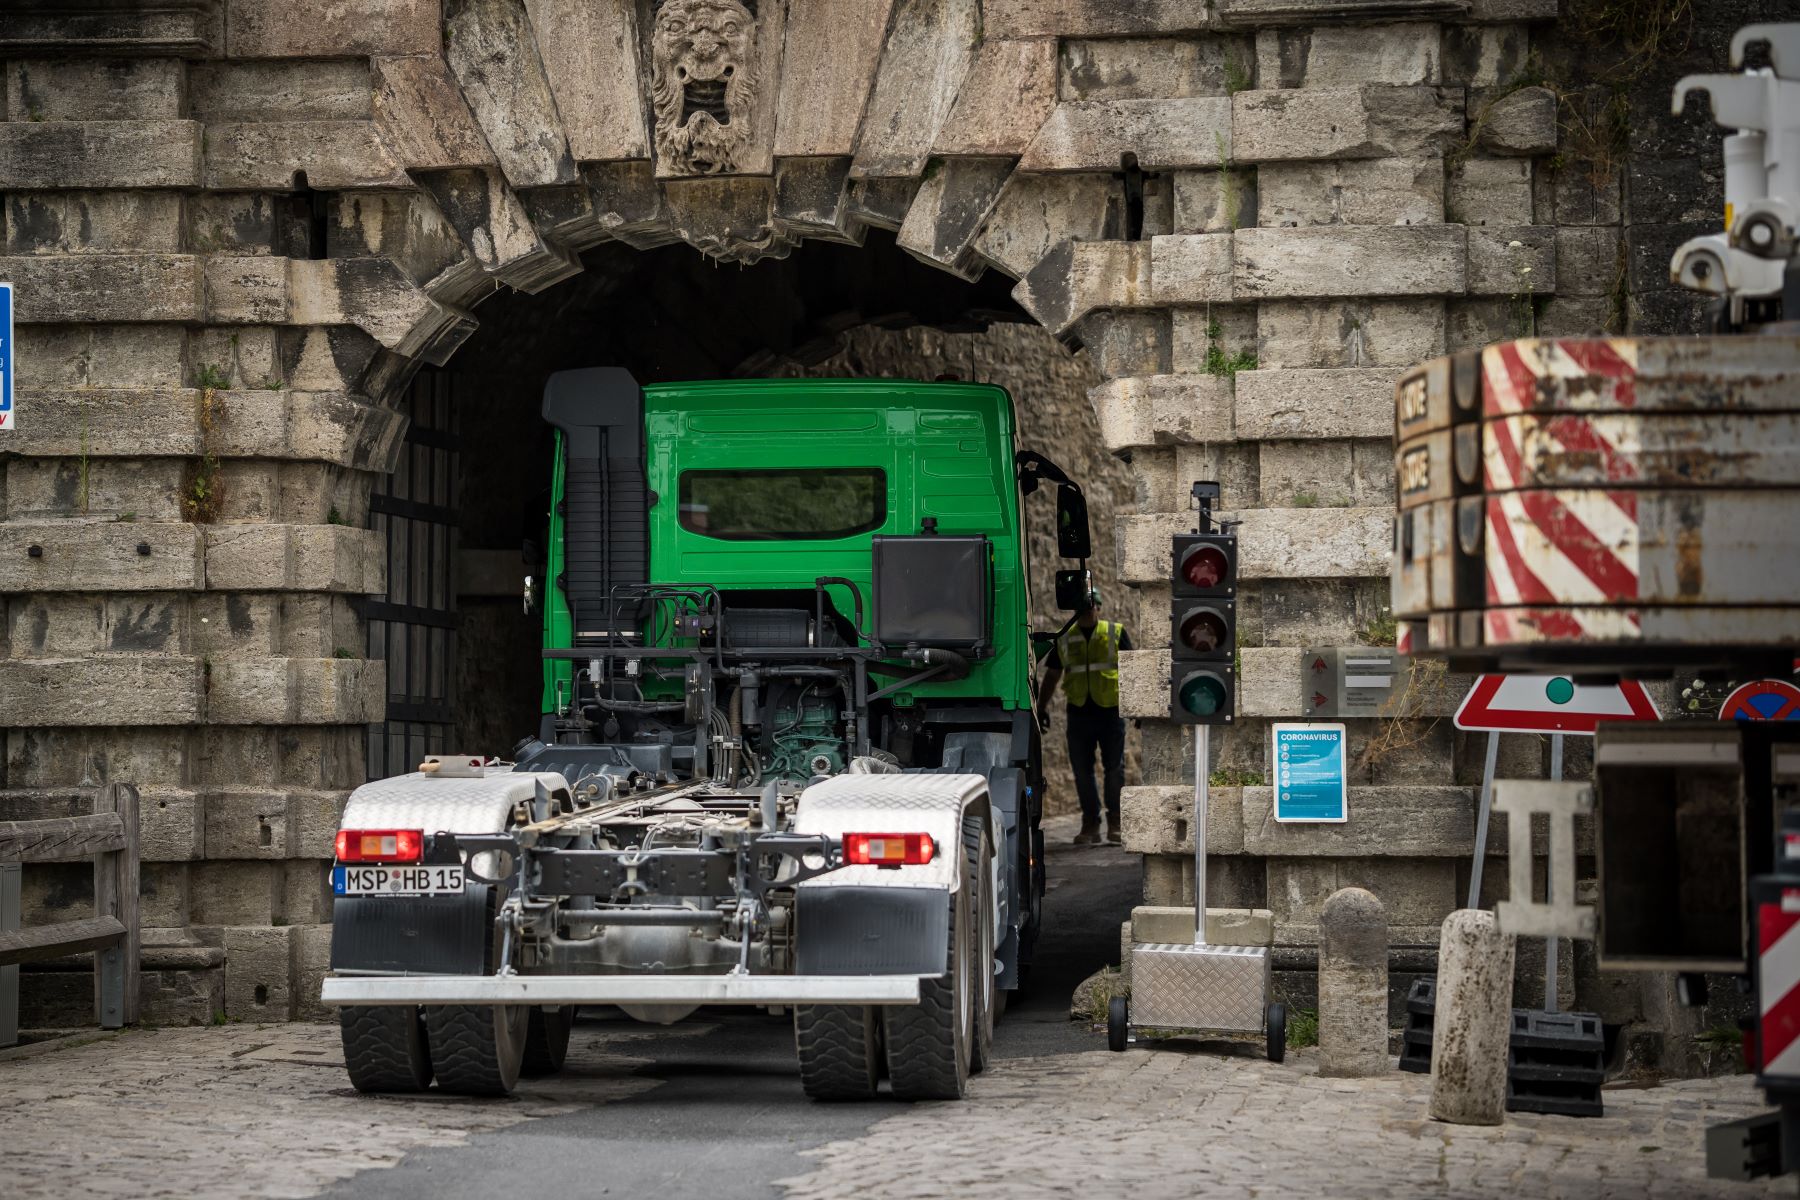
794,887,950,975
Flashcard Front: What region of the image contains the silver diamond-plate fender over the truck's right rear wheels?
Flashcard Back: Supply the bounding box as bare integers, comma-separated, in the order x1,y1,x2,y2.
794,775,995,892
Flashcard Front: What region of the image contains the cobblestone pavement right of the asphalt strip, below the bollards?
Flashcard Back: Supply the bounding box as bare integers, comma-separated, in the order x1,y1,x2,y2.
783,1042,1793,1200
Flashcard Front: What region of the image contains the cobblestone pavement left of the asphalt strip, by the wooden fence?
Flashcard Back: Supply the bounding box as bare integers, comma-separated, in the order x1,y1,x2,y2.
0,1025,655,1200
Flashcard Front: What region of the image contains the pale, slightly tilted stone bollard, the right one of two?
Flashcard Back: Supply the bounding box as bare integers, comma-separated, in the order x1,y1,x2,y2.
1431,909,1512,1124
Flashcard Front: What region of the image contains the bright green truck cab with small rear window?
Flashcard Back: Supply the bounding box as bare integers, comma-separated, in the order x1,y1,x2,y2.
518,369,1089,988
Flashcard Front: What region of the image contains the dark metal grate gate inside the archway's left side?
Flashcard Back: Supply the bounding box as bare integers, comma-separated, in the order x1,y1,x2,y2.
364,371,457,779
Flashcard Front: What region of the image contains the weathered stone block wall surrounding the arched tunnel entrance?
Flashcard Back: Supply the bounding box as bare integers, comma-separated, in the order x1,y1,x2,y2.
0,0,1699,1020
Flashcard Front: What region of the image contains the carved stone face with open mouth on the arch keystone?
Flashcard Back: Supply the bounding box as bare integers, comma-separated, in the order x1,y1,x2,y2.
650,0,758,175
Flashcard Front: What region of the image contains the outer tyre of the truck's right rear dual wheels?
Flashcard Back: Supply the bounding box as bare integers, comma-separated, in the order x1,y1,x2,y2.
882,859,976,1099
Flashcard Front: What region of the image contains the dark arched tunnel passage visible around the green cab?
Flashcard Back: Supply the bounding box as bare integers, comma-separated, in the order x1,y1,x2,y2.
369,230,1129,802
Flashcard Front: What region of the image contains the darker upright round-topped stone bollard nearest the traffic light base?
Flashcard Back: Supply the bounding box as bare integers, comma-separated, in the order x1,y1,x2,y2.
1319,887,1393,1078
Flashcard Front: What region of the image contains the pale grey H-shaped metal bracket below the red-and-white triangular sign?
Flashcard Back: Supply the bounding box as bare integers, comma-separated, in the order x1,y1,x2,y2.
1494,779,1595,939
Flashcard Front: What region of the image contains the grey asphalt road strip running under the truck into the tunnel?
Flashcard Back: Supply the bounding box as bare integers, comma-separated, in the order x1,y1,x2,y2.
324,820,1139,1200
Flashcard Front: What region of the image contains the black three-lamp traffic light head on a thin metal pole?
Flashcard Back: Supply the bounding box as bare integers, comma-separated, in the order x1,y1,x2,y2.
1168,533,1237,725
